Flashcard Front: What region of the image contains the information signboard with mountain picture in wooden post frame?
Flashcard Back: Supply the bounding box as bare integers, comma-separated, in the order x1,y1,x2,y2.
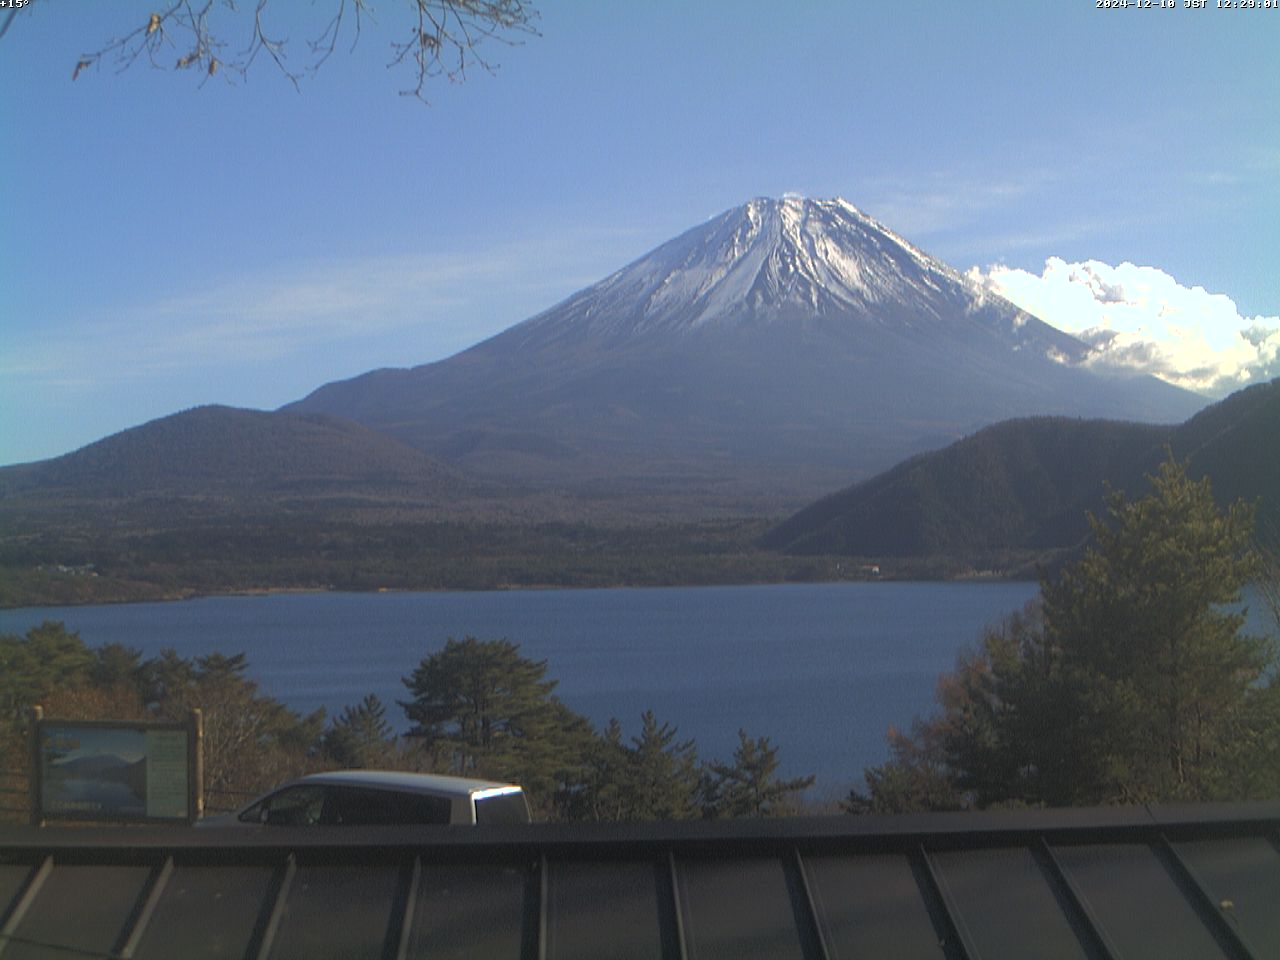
32,714,202,823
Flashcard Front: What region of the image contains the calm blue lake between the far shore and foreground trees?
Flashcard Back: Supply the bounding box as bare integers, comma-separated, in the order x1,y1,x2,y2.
0,582,1037,800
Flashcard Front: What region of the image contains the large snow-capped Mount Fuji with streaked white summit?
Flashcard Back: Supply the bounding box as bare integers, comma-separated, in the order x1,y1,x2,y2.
288,197,1207,512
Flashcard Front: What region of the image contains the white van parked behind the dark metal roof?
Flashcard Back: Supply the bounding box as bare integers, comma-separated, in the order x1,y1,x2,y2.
197,771,531,827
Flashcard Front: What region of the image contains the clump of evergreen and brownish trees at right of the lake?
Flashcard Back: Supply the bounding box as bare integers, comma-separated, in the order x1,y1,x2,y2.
850,458,1280,809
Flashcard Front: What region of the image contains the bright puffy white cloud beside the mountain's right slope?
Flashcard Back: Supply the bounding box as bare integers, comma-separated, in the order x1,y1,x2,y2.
969,257,1280,397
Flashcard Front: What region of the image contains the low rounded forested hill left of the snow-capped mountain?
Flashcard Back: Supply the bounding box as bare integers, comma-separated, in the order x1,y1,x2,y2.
0,406,462,499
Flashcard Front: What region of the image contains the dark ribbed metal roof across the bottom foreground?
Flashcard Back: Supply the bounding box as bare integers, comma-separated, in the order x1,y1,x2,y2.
0,804,1280,960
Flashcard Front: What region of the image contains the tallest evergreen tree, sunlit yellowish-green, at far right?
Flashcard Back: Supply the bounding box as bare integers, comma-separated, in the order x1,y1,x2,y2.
1030,458,1274,803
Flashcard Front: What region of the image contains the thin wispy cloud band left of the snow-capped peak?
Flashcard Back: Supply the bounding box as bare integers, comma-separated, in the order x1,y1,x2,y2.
0,227,620,386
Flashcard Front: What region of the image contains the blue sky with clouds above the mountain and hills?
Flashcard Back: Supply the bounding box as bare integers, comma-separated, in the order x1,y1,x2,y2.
0,0,1280,463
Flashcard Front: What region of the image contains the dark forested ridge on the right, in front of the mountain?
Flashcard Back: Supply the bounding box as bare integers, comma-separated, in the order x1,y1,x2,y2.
763,380,1280,557
